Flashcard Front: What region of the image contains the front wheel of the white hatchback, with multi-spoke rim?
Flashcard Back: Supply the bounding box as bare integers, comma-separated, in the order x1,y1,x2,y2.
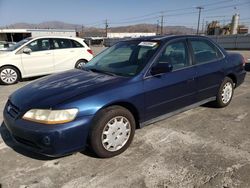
0,66,21,85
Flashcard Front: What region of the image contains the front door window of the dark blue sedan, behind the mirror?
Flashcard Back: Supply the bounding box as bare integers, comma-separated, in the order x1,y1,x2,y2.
157,41,189,70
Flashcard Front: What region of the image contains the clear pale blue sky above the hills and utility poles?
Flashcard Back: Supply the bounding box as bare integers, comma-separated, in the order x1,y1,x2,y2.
0,0,250,28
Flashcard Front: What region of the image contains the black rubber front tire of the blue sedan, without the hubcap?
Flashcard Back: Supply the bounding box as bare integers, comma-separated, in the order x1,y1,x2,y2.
90,106,135,158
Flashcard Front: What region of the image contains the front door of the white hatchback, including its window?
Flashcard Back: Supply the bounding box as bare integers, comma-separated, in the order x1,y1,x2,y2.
21,38,54,76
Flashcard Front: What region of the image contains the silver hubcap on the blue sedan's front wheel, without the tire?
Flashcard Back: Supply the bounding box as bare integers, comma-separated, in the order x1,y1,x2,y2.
102,116,131,152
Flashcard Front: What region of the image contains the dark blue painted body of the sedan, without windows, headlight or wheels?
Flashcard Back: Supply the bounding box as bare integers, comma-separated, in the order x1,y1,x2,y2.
4,36,246,156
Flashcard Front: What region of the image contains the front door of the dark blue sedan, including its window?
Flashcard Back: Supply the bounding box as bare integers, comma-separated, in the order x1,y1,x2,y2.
144,40,197,120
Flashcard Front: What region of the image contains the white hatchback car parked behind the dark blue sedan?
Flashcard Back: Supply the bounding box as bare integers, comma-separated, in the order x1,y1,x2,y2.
0,36,93,85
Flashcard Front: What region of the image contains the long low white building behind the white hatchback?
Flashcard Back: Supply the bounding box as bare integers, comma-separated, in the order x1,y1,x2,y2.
0,29,76,42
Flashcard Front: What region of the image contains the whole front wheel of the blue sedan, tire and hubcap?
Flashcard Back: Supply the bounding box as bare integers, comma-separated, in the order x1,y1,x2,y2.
90,106,135,158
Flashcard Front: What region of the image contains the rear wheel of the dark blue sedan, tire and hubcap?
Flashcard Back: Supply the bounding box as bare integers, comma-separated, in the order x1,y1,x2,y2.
215,77,234,108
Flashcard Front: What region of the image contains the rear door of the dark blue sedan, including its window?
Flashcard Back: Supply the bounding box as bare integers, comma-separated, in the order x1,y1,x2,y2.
189,38,226,101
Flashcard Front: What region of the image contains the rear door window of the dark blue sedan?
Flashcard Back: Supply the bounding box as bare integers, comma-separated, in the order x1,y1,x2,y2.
190,40,223,64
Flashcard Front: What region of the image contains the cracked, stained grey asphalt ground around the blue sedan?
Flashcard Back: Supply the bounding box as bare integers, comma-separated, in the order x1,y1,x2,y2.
0,48,250,188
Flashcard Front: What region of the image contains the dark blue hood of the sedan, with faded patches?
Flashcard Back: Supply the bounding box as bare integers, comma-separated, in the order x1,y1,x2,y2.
10,69,126,110
